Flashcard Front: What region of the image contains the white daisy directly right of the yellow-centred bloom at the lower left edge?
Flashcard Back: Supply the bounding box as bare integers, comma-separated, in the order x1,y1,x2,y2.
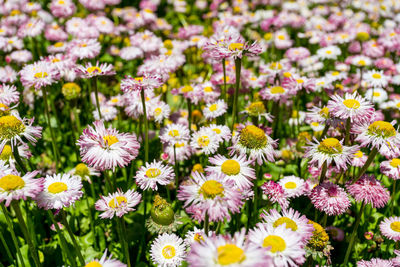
35,173,83,210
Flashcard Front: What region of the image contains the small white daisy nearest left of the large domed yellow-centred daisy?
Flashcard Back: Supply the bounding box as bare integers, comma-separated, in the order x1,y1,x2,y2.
190,127,219,155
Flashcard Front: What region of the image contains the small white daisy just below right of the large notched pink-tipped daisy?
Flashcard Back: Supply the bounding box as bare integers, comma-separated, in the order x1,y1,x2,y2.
135,160,175,191
